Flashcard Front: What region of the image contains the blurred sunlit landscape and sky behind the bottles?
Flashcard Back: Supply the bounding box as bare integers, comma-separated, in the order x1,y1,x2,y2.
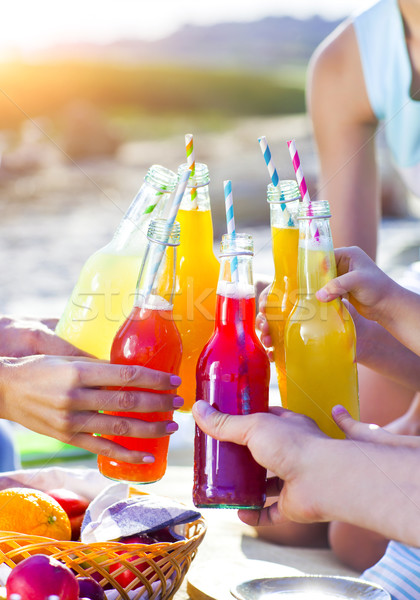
0,0,418,316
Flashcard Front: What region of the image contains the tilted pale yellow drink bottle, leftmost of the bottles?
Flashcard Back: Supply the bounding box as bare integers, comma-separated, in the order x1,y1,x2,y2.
55,165,178,359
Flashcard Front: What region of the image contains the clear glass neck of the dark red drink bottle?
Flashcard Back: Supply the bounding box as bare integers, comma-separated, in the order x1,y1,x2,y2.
215,254,255,336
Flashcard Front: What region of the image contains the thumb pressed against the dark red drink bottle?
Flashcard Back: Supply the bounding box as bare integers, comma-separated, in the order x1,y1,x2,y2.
192,400,246,446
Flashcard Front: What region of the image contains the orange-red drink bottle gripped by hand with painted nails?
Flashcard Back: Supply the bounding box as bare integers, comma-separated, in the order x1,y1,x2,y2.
98,219,182,483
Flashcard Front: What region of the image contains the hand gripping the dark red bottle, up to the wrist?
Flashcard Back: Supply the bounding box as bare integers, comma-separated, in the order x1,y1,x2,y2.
192,401,329,526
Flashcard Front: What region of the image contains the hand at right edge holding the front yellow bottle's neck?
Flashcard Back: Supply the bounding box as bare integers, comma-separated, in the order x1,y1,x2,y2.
316,246,420,354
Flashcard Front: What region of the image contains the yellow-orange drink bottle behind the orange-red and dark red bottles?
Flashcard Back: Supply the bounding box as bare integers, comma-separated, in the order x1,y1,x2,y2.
173,163,220,412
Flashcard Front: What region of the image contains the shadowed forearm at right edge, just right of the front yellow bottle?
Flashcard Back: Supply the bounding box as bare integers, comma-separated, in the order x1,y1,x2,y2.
357,322,420,390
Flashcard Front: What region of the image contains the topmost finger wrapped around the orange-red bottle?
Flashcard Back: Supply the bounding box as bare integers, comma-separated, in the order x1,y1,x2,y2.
72,361,181,390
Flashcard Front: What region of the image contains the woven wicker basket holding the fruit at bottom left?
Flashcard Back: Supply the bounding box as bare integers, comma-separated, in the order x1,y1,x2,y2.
0,518,206,600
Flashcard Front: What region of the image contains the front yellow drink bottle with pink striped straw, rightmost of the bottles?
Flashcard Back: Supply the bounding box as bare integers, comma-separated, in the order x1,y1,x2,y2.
285,200,359,438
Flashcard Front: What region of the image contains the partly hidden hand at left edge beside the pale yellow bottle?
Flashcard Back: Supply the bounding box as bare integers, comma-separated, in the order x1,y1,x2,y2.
0,316,90,358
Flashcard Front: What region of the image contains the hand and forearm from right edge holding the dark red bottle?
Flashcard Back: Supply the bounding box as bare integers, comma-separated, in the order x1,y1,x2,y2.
193,402,420,546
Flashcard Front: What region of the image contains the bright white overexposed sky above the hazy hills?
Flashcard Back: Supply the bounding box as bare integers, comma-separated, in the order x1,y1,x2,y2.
0,0,366,54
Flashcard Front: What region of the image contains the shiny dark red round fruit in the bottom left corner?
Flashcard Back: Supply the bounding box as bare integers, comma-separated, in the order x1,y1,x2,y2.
6,554,79,600
